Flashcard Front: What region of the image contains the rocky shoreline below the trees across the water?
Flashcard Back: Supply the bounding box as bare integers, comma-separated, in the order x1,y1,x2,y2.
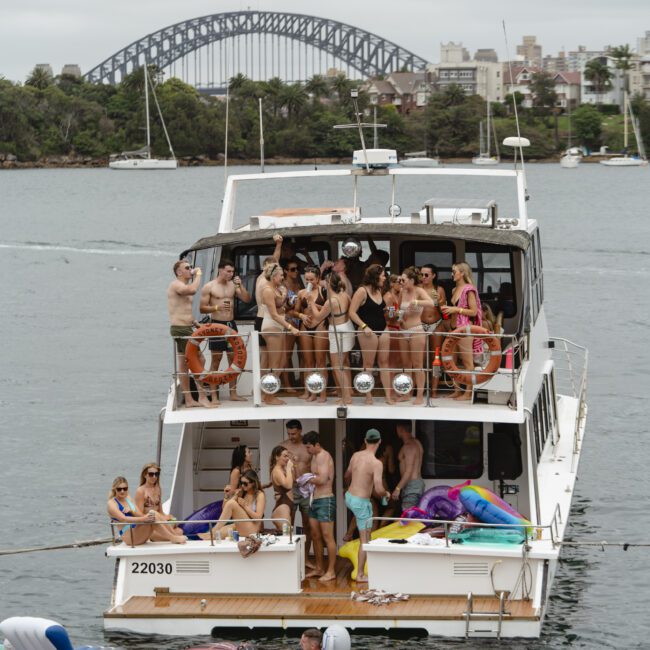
0,153,608,169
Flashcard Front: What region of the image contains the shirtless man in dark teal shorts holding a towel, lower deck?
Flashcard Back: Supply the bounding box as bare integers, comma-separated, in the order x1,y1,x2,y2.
302,431,336,582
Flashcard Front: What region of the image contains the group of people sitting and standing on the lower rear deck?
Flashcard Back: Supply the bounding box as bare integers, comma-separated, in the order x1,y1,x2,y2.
107,420,425,582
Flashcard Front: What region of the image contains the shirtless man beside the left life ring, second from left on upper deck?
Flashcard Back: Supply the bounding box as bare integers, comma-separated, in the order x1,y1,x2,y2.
200,259,251,406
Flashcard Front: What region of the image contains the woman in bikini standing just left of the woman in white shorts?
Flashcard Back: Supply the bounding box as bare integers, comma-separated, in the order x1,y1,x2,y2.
295,266,328,402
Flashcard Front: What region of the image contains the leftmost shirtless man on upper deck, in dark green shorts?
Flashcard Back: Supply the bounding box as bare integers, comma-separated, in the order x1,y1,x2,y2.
167,260,211,407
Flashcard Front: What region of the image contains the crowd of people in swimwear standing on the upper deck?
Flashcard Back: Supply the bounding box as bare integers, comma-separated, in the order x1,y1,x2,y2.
168,235,501,407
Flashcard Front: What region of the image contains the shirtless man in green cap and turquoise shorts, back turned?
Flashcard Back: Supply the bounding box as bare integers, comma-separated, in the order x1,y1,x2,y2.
343,429,390,582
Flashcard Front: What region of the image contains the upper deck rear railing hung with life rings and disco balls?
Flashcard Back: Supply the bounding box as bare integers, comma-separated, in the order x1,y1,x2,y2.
173,330,525,409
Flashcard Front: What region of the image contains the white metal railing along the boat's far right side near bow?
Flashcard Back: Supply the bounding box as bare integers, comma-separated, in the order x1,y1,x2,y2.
551,338,589,460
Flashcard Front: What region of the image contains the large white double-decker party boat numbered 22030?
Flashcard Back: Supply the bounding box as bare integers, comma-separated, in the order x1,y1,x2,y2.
103,151,587,638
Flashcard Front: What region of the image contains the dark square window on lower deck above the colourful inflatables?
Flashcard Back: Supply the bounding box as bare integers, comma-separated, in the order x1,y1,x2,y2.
415,420,483,480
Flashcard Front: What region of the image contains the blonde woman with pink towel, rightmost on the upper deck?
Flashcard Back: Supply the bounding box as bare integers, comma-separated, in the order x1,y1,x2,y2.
442,262,483,400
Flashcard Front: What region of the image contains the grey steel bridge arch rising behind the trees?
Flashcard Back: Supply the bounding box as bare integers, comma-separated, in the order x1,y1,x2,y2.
84,10,427,85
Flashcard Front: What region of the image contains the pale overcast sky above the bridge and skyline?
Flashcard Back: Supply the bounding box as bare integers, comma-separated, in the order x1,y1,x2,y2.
0,0,650,81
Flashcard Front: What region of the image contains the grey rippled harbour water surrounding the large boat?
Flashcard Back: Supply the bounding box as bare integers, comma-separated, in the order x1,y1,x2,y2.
0,164,650,650
